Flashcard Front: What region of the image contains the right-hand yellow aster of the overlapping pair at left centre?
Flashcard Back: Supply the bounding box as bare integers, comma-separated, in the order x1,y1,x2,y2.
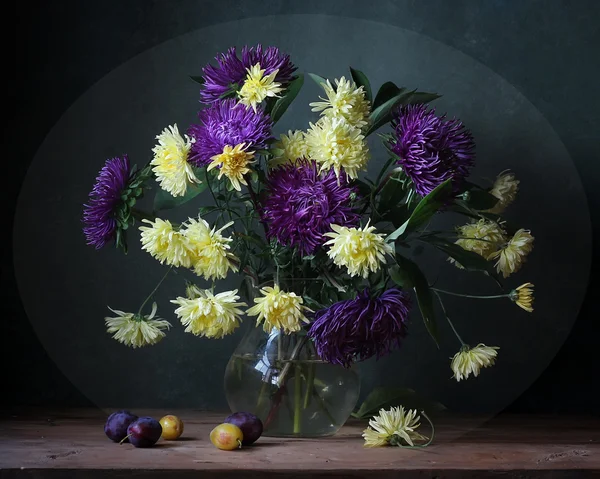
181,218,239,280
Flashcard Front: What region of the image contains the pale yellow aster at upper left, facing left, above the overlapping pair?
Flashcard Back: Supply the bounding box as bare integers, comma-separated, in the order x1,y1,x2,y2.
150,125,200,196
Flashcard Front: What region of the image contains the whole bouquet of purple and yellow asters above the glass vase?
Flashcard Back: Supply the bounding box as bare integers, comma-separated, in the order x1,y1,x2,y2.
83,45,533,442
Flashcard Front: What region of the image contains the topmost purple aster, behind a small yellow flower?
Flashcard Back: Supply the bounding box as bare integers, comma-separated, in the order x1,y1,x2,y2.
200,45,296,103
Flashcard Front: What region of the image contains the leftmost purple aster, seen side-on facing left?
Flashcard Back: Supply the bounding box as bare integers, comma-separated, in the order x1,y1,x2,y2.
83,155,131,249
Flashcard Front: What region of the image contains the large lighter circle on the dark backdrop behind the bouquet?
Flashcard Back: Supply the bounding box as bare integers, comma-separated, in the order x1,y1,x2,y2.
14,15,591,413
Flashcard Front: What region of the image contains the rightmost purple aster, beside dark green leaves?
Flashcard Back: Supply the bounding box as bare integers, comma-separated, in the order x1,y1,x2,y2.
390,105,475,196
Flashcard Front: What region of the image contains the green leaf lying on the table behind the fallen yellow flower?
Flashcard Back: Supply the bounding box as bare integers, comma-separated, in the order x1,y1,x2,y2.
352,387,446,419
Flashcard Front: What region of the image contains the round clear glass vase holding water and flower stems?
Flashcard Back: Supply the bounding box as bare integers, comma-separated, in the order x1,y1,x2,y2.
225,327,360,437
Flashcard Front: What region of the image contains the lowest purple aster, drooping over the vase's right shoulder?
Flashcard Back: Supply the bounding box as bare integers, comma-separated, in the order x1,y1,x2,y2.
309,288,411,367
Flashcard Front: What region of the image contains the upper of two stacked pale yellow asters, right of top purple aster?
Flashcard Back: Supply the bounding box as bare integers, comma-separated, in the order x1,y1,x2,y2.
310,77,371,128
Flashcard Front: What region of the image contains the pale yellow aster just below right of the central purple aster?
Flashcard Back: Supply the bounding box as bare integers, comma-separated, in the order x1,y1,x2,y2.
324,220,394,278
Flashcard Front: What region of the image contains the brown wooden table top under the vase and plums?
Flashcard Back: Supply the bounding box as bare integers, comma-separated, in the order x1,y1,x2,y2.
0,409,600,479
